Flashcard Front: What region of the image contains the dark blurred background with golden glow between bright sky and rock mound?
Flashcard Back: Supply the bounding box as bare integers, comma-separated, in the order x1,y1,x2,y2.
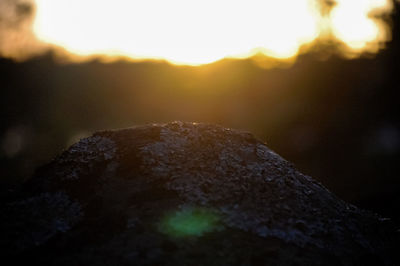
0,0,400,222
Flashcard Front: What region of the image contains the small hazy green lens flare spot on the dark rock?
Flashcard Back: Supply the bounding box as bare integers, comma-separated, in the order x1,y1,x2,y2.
160,207,218,237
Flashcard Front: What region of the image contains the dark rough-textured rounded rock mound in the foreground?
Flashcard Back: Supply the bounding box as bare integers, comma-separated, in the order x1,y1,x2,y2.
0,122,398,265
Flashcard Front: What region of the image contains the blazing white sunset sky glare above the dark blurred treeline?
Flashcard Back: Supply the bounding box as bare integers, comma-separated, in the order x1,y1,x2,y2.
34,0,391,65
